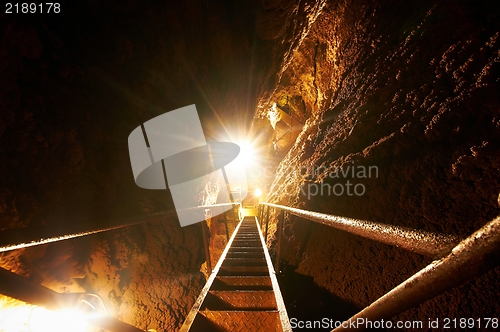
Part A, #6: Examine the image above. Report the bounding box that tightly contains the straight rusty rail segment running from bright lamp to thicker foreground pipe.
[260,202,460,258]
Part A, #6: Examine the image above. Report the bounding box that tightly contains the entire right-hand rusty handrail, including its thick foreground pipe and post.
[261,203,500,332]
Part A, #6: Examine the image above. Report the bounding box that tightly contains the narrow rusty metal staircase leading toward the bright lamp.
[181,216,292,332]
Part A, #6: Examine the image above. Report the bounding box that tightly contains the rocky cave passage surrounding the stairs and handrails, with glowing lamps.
[0,0,500,332]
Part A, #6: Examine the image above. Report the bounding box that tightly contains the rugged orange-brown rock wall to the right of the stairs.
[259,0,500,321]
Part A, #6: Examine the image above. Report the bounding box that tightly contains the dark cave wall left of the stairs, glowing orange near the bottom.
[0,0,323,331]
